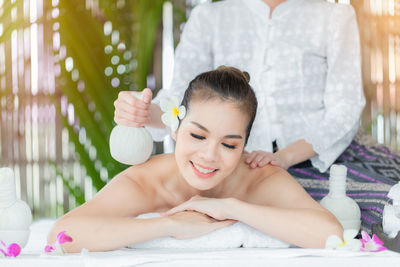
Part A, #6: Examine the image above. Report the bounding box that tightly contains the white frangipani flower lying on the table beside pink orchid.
[325,229,362,251]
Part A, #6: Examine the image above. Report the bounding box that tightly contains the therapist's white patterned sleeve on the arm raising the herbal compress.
[146,3,213,141]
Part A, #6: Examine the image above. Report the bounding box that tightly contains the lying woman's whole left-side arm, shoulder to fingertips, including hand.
[48,163,234,252]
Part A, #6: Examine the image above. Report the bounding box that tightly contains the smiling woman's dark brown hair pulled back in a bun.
[181,66,257,145]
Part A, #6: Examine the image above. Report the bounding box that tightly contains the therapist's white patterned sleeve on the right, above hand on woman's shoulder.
[305,4,365,175]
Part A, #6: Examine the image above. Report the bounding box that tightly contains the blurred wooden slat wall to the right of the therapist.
[352,0,400,150]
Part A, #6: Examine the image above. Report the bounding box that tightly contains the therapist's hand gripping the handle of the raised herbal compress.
[114,88,153,127]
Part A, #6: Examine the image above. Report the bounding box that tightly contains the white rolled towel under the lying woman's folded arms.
[128,213,289,249]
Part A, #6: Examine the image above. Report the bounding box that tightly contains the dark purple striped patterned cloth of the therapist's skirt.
[289,131,400,234]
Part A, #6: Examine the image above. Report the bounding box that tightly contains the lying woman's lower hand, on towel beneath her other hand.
[166,211,236,239]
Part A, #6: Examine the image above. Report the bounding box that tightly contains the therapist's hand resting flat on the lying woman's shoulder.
[244,150,291,170]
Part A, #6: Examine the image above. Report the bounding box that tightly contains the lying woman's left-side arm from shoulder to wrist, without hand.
[48,172,166,252]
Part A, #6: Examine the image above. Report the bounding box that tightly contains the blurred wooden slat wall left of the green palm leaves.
[0,0,91,218]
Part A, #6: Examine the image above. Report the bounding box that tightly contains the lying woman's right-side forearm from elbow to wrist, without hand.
[223,198,343,248]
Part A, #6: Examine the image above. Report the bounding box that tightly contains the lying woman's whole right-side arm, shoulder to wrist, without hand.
[226,166,343,248]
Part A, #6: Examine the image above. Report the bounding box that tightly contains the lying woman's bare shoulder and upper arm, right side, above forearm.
[242,164,323,213]
